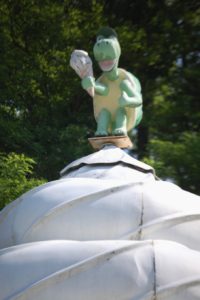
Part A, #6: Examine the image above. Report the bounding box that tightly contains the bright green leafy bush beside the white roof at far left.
[0,153,45,209]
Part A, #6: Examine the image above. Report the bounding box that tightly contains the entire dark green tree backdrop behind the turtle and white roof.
[0,0,200,207]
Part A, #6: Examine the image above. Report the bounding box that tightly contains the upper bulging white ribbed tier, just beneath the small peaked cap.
[0,178,200,250]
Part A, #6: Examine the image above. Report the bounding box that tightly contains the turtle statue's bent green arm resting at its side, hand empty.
[119,79,142,107]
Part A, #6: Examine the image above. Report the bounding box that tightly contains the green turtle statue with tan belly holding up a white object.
[70,27,142,146]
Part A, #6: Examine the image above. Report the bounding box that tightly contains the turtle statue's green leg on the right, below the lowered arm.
[112,107,127,135]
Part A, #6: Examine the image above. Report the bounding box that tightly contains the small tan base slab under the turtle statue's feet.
[88,135,133,150]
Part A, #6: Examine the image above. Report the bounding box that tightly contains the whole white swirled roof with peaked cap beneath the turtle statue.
[0,146,200,300]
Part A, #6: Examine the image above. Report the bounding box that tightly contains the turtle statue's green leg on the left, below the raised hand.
[95,108,111,136]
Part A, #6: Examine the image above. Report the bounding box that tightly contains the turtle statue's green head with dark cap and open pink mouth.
[93,27,121,72]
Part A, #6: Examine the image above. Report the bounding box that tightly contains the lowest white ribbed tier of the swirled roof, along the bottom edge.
[0,241,200,300]
